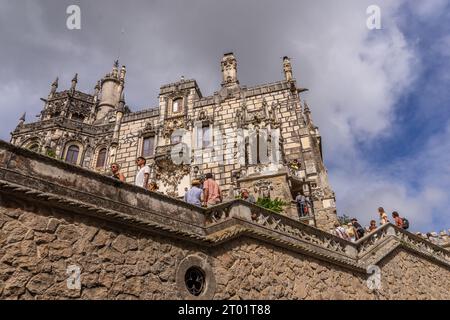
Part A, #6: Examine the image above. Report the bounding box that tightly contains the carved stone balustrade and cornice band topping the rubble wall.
[0,141,450,272]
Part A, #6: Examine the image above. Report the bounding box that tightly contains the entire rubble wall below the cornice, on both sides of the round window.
[0,199,450,300]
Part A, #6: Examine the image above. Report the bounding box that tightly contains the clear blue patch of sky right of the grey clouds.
[328,1,450,231]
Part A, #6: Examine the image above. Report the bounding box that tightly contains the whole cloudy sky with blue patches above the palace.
[0,0,450,231]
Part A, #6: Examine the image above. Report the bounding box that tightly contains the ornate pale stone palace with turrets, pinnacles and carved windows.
[11,53,336,230]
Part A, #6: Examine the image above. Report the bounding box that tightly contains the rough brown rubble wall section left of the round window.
[0,203,197,299]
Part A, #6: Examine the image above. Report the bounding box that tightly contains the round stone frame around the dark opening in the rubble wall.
[175,253,217,300]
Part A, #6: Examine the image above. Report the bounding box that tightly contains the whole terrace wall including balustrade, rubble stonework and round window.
[0,141,450,300]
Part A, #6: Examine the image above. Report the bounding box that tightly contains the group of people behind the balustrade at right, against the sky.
[334,207,409,242]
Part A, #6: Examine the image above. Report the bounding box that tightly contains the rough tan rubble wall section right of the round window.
[215,239,450,300]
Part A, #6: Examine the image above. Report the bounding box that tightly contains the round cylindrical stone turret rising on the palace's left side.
[96,60,126,120]
